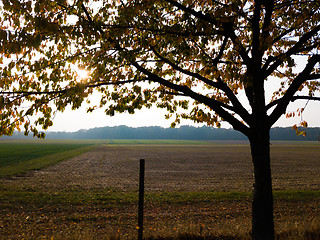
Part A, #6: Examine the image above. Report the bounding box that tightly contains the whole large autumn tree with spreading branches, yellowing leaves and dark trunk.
[0,0,320,239]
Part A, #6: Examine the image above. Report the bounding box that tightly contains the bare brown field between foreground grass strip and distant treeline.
[2,144,320,191]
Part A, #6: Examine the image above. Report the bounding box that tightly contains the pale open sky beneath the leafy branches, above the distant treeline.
[48,96,320,132]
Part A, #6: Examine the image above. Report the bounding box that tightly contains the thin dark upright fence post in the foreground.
[138,159,145,240]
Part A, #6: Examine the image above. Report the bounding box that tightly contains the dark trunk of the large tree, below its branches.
[249,128,275,240]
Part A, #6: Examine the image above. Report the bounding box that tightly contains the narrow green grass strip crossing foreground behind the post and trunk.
[0,188,320,206]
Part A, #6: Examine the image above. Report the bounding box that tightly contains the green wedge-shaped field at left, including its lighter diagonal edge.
[0,140,102,177]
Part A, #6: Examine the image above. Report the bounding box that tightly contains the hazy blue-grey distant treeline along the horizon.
[5,126,320,141]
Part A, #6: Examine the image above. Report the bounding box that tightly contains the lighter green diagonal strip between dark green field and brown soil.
[0,145,95,177]
